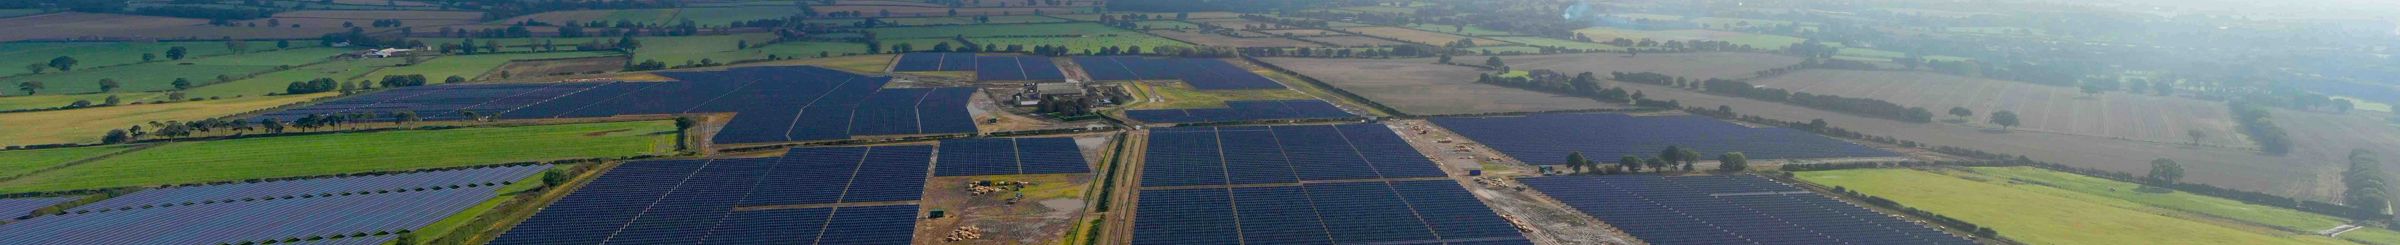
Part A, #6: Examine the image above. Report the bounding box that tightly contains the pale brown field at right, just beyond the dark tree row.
[1752,70,2251,149]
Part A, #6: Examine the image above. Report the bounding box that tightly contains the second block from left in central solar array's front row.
[1234,187,1334,245]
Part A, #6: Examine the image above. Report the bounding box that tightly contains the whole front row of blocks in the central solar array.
[1133,180,1531,245]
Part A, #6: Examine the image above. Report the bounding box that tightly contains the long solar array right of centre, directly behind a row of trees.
[1433,113,1898,163]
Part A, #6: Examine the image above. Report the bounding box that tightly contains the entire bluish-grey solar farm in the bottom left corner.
[0,166,550,245]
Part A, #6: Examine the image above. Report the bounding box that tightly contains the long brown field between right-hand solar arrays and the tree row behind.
[1615,82,2350,199]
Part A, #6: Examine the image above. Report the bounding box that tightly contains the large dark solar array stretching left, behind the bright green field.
[259,67,974,144]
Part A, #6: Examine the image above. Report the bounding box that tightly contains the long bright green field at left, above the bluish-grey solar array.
[0,120,674,192]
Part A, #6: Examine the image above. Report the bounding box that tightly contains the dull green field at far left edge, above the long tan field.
[0,43,343,96]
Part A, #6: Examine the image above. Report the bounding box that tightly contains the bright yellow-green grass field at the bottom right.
[1798,168,2342,245]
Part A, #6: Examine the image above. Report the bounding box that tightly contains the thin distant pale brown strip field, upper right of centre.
[1452,53,1800,79]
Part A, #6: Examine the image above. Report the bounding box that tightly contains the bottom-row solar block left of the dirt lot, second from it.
[703,207,833,245]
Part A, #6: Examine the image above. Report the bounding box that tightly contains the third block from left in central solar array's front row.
[1306,183,1435,243]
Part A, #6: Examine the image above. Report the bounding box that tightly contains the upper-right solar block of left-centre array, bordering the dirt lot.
[842,147,934,202]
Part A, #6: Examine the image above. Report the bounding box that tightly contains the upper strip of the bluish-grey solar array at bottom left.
[77,166,550,211]
